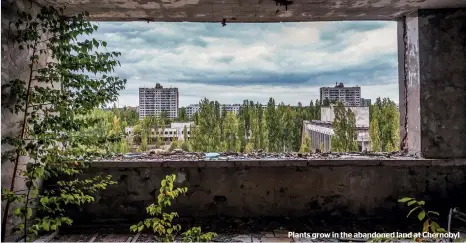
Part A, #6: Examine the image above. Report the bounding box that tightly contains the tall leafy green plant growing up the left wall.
[2,6,126,241]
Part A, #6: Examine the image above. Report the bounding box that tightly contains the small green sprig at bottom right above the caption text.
[398,197,447,233]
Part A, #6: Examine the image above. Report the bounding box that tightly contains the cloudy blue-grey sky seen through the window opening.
[95,21,398,106]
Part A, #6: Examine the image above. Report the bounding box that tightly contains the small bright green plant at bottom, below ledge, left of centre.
[130,174,217,242]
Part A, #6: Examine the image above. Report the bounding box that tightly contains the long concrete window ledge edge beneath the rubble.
[90,159,466,168]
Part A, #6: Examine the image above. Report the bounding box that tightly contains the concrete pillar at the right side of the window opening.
[398,9,466,158]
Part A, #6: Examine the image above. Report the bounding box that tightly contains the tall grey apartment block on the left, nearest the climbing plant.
[139,83,179,119]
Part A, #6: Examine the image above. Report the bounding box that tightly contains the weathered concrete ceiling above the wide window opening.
[36,0,466,21]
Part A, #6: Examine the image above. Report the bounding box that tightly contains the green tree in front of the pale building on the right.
[332,102,358,152]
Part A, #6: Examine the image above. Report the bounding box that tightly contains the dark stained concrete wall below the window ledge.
[58,160,466,224]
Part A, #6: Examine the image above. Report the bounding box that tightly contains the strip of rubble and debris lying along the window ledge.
[96,149,422,162]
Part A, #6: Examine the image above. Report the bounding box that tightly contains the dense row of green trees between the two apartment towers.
[190,98,320,152]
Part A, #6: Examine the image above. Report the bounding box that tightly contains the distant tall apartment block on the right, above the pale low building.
[320,83,361,106]
